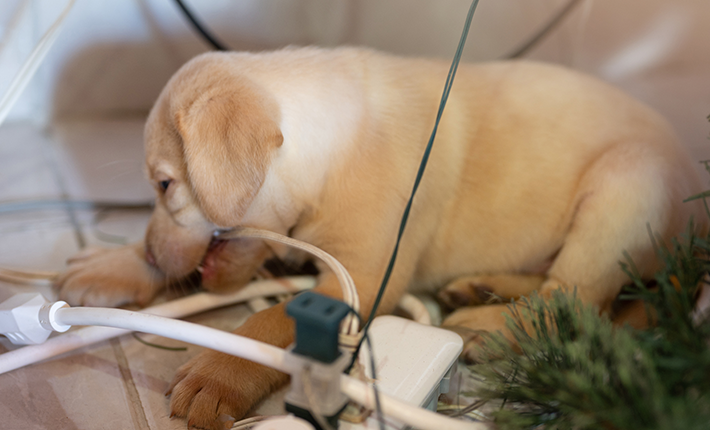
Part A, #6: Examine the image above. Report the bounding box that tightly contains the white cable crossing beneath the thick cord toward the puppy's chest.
[0,276,316,374]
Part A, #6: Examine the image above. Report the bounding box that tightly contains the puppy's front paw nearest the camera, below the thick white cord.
[166,351,288,430]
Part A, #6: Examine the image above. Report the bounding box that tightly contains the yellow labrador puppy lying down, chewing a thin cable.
[57,48,704,428]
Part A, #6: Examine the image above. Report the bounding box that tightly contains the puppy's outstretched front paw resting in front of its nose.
[54,244,165,307]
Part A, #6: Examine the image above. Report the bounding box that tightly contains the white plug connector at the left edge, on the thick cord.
[0,293,71,345]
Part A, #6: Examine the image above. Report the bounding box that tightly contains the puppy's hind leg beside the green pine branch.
[442,144,705,361]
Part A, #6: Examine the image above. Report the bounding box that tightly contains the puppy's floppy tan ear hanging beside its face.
[175,82,283,227]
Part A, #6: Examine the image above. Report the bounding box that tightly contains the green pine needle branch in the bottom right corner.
[474,220,710,430]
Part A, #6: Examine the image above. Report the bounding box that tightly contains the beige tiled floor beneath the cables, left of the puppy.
[0,119,290,430]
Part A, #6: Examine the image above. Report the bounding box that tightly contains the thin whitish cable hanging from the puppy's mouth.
[217,227,360,336]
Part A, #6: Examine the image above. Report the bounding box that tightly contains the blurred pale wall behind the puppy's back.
[0,0,710,158]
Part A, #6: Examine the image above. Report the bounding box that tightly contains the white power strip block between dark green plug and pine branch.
[339,316,463,430]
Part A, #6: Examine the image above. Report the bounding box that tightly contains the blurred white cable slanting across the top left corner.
[0,0,76,125]
